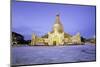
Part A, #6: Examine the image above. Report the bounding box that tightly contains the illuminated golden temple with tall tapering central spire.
[31,14,81,45]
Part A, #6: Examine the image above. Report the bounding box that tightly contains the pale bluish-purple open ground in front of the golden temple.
[11,45,96,65]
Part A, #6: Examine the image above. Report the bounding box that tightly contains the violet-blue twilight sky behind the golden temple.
[12,1,96,40]
